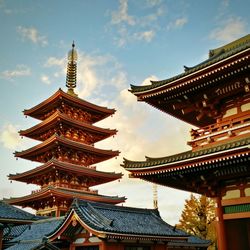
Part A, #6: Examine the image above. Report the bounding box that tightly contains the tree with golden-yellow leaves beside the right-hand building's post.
[177,194,216,250]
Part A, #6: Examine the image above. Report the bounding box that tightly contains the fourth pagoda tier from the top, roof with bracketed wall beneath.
[9,159,122,187]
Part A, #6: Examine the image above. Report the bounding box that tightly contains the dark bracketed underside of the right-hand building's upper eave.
[138,61,250,127]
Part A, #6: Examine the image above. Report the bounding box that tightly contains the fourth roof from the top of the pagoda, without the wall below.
[9,159,122,185]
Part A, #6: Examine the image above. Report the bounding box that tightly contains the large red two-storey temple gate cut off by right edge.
[123,35,250,250]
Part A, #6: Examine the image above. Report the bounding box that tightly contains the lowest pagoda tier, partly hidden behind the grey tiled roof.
[5,186,125,216]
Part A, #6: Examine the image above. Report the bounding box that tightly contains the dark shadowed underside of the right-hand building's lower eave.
[131,154,250,197]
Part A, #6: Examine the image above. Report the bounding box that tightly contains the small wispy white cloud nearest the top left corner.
[17,26,48,46]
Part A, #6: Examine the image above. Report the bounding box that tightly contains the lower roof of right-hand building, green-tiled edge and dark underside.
[123,137,250,194]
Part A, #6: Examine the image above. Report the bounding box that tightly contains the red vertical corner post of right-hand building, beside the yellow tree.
[216,196,227,250]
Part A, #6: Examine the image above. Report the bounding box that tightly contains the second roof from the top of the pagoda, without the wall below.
[19,110,117,142]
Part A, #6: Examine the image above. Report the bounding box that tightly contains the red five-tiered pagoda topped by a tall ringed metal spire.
[6,43,125,217]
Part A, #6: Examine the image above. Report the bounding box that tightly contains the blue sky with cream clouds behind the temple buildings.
[0,0,250,225]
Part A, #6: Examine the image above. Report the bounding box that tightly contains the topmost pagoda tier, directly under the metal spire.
[23,89,115,124]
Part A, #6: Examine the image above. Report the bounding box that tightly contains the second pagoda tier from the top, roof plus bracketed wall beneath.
[19,110,117,144]
